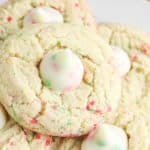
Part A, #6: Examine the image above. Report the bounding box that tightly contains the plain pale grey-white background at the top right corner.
[87,0,150,32]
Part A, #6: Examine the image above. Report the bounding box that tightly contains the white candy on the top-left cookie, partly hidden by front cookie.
[24,6,64,26]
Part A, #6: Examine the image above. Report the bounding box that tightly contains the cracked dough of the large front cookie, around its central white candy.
[0,24,121,137]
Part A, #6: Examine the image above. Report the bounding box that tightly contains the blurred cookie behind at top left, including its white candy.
[0,0,96,39]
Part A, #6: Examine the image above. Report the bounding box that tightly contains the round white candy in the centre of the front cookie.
[40,49,84,92]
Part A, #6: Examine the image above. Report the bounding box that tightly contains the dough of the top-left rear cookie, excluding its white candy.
[0,0,96,39]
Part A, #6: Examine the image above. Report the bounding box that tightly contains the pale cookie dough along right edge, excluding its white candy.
[99,24,150,150]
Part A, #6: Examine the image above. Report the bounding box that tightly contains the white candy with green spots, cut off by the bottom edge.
[81,124,128,150]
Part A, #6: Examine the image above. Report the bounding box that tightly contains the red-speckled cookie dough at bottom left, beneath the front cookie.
[0,105,81,150]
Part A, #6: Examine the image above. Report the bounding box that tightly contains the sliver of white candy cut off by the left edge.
[0,106,7,129]
